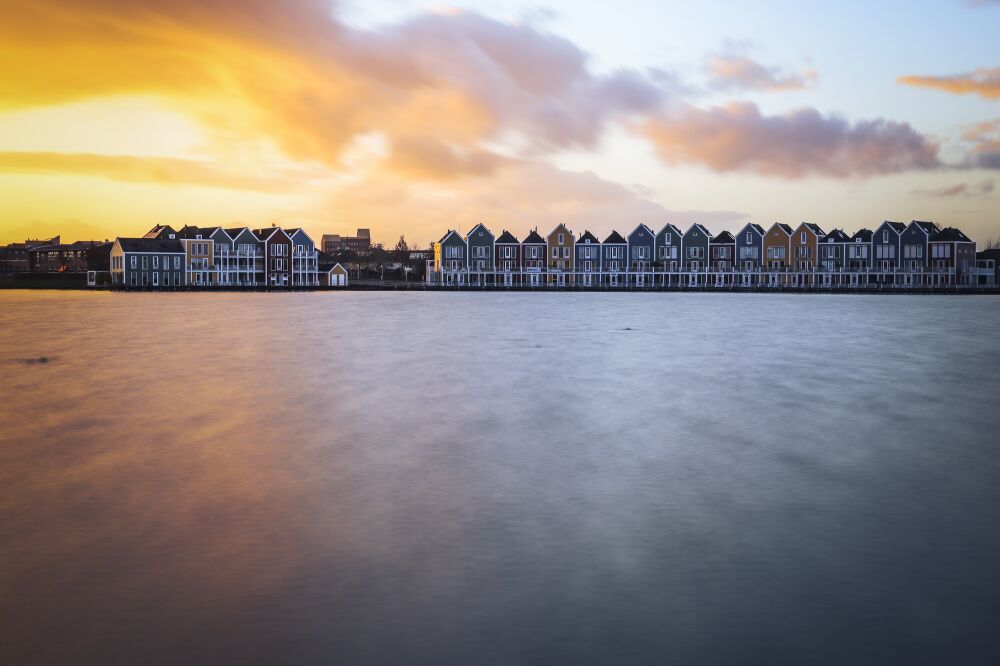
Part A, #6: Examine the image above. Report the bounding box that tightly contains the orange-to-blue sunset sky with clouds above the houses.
[0,0,1000,246]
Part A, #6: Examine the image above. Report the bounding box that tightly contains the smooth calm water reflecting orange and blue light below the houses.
[0,292,1000,665]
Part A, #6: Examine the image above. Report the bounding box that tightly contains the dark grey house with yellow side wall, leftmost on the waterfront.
[111,238,186,289]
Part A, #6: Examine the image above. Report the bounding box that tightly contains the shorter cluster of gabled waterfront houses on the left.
[110,225,348,289]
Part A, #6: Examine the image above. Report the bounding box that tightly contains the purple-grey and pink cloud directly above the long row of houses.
[643,102,941,179]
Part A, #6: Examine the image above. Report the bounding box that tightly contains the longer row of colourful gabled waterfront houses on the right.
[426,220,996,288]
